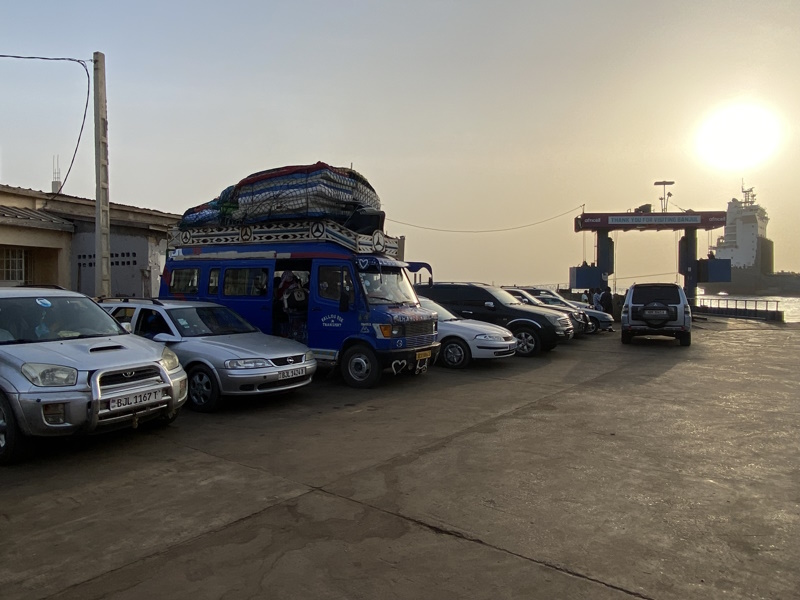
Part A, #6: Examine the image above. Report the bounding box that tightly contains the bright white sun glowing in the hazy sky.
[696,104,781,171]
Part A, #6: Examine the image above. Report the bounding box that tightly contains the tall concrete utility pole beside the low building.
[92,52,111,296]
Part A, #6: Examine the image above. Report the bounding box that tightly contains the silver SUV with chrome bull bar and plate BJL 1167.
[0,287,187,463]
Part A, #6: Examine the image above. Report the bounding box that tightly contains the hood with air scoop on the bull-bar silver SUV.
[0,334,164,371]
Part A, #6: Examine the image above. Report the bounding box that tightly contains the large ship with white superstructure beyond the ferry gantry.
[702,186,800,296]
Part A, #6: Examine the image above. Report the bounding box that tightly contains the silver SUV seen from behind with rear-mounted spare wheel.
[621,283,692,346]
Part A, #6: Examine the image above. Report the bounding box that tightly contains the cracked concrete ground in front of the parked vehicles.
[0,319,800,600]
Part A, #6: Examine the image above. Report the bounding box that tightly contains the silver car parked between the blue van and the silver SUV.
[100,298,317,412]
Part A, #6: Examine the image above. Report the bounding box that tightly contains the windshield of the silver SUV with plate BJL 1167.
[0,292,125,344]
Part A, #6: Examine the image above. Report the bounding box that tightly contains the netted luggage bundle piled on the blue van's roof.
[179,162,382,229]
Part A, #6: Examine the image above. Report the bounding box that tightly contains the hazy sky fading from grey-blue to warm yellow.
[0,0,800,287]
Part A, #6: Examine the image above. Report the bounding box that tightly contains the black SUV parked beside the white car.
[414,283,574,356]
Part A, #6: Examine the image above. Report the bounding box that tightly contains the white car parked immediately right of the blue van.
[419,297,517,369]
